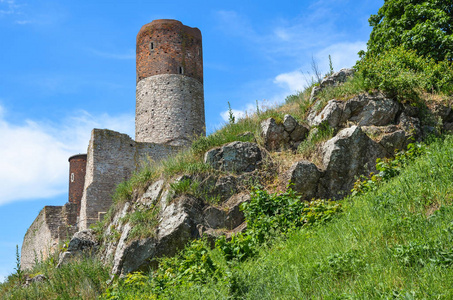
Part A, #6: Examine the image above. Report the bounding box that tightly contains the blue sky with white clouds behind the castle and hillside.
[0,0,384,280]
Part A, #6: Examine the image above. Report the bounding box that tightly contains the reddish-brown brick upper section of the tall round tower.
[136,19,203,83]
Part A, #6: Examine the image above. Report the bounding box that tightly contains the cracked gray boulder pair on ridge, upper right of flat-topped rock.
[261,115,309,151]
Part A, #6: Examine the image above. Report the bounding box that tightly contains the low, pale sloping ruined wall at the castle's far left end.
[20,206,64,269]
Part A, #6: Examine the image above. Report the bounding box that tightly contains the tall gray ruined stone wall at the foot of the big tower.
[79,129,180,230]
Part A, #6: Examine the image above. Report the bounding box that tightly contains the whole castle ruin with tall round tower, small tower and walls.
[21,20,205,268]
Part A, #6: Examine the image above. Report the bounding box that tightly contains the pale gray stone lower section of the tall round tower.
[135,75,205,146]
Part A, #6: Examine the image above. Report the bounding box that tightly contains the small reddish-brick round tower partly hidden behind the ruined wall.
[68,154,87,217]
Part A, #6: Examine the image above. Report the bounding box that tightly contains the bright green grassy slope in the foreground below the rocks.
[100,136,453,299]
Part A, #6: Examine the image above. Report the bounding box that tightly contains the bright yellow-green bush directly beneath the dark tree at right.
[356,47,453,100]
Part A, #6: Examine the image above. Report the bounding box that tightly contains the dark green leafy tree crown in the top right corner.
[367,0,453,61]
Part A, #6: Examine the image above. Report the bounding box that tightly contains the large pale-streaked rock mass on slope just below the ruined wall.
[93,175,250,276]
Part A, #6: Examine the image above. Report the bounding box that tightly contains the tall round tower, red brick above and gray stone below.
[135,20,206,146]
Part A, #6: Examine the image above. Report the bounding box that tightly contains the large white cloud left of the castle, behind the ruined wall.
[0,106,134,205]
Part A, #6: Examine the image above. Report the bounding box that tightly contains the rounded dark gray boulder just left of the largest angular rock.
[284,161,321,200]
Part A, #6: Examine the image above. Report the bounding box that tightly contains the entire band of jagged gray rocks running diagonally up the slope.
[47,77,453,276]
